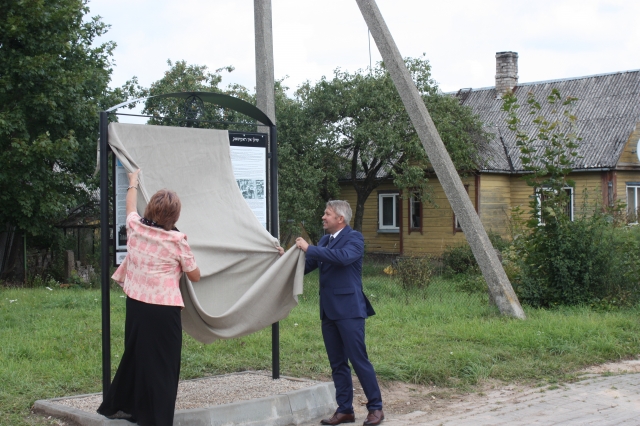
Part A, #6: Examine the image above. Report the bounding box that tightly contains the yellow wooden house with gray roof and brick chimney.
[341,52,640,255]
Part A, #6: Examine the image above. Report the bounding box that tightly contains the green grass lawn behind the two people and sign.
[0,269,640,426]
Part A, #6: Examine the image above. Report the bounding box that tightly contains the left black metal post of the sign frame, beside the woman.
[100,111,111,397]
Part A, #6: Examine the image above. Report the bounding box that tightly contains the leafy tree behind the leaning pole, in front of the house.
[296,58,487,230]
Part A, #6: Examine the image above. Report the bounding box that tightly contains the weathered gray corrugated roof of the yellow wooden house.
[456,70,640,173]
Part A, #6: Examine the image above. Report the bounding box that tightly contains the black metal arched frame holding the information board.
[99,92,280,396]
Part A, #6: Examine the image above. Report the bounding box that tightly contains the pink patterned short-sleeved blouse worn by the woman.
[111,212,197,307]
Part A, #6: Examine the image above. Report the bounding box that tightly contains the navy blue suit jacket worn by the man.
[304,225,375,320]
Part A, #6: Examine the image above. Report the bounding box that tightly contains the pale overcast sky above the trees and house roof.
[89,0,640,100]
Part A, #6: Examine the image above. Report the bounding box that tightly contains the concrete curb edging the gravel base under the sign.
[33,377,336,426]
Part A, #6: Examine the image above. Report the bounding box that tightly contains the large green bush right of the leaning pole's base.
[513,213,640,309]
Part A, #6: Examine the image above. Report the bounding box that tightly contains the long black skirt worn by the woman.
[98,297,182,426]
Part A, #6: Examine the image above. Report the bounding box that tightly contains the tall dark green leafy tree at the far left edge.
[0,0,115,235]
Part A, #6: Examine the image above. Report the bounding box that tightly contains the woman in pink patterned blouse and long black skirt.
[98,170,200,426]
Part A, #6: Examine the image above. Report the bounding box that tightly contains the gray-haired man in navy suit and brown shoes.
[296,200,384,426]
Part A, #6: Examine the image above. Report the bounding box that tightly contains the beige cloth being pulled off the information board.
[109,123,304,343]
